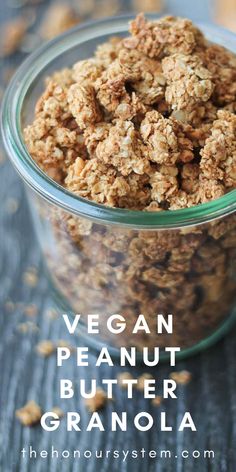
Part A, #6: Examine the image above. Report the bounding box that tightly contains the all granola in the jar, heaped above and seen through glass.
[24,15,236,349]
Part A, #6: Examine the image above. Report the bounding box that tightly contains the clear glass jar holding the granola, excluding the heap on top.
[2,16,236,357]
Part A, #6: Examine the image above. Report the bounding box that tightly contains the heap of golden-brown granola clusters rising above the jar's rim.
[25,14,236,211]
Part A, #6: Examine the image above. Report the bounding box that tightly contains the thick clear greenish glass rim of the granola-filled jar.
[1,15,236,229]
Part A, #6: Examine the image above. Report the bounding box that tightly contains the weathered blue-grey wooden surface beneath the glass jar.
[0,2,236,472]
